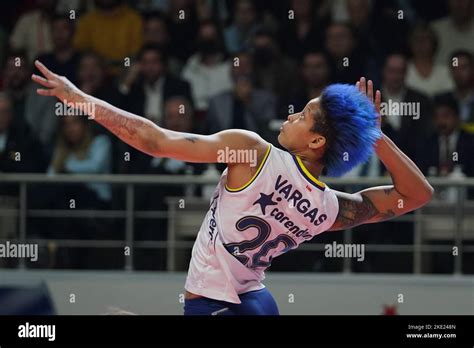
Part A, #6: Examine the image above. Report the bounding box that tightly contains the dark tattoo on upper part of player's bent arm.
[335,194,395,229]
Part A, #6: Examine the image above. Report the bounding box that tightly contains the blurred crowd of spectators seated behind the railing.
[0,0,474,272]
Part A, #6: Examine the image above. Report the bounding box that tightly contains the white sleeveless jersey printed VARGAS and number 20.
[185,144,339,303]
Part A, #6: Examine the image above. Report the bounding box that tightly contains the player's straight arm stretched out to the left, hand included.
[32,61,267,163]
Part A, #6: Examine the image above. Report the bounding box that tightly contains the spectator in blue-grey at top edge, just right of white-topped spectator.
[224,0,259,54]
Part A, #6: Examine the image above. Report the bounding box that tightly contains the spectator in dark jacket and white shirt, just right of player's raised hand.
[381,53,433,158]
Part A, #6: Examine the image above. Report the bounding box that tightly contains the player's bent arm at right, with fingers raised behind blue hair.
[330,78,434,230]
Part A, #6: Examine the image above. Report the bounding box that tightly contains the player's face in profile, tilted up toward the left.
[278,98,324,152]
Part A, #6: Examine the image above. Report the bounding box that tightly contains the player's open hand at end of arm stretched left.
[31,60,84,103]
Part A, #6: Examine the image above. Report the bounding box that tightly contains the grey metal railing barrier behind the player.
[0,174,474,274]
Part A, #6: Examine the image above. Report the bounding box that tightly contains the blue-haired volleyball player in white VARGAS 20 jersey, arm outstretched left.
[32,62,433,315]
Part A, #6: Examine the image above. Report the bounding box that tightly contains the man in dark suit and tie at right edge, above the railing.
[419,96,474,176]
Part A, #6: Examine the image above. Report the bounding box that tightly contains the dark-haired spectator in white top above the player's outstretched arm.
[182,21,232,114]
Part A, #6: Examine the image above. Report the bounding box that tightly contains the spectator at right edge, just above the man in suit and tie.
[436,50,474,133]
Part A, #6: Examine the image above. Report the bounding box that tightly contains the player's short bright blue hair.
[315,84,381,177]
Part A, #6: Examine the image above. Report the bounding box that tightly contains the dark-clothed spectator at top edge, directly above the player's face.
[278,0,328,60]
